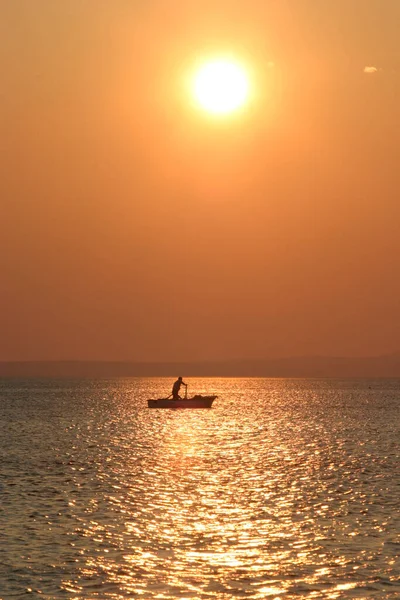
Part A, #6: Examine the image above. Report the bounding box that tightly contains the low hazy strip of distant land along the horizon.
[0,354,400,378]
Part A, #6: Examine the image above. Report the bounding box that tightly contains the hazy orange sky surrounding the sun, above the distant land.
[0,0,400,360]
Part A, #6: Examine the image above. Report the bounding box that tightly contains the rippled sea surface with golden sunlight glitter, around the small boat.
[0,379,400,600]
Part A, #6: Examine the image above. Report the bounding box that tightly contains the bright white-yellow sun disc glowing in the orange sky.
[193,59,249,115]
